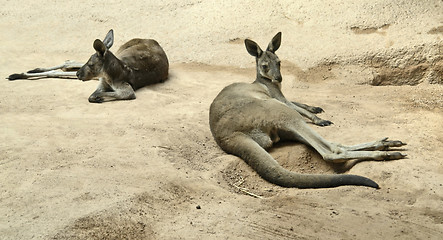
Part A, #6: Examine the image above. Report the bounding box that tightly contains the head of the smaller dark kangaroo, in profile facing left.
[77,29,114,81]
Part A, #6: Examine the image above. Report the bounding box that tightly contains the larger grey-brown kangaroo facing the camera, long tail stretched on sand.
[209,32,406,188]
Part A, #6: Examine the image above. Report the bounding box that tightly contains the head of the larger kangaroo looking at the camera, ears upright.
[245,32,282,83]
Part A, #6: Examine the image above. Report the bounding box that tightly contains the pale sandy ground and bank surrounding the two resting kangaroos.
[0,0,443,239]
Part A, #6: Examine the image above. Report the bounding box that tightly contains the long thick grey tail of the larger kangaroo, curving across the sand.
[224,135,379,188]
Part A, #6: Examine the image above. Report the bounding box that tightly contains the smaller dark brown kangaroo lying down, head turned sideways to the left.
[9,29,169,103]
